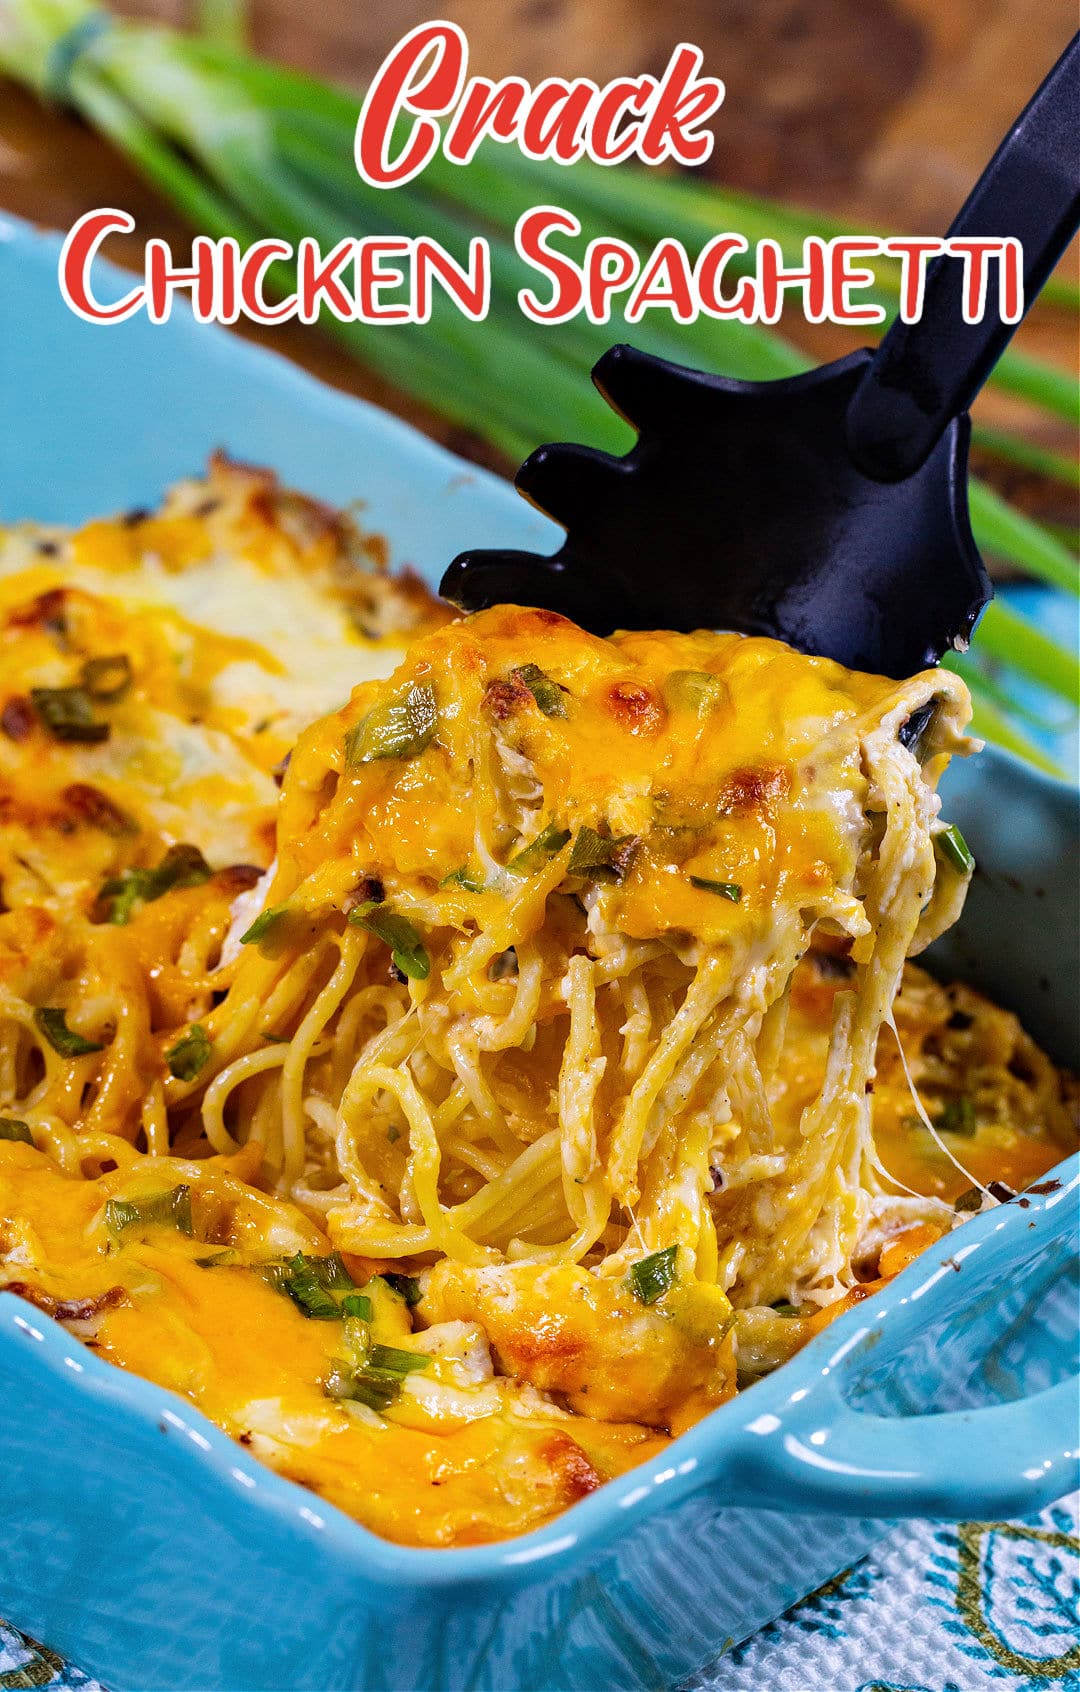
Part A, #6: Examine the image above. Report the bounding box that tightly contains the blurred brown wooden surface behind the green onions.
[0,0,1077,521]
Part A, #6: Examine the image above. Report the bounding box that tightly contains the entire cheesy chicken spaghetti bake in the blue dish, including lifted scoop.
[0,477,1075,1545]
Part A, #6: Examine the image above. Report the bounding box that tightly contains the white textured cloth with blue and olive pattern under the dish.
[0,1497,1080,1692]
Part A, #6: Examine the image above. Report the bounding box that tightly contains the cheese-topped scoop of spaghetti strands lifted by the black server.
[184,606,968,1420]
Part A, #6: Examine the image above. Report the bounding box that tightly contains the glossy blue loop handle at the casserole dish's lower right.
[731,1354,1080,1521]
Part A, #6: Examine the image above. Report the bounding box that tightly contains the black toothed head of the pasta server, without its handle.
[442,347,992,677]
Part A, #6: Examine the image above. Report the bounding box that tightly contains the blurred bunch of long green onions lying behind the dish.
[0,0,1080,773]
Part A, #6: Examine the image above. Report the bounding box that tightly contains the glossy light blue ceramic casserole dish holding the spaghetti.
[0,218,1080,1692]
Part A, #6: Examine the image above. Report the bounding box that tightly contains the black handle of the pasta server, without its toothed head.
[846,36,1080,482]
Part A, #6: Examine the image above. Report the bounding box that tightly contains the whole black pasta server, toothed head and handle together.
[442,36,1080,677]
